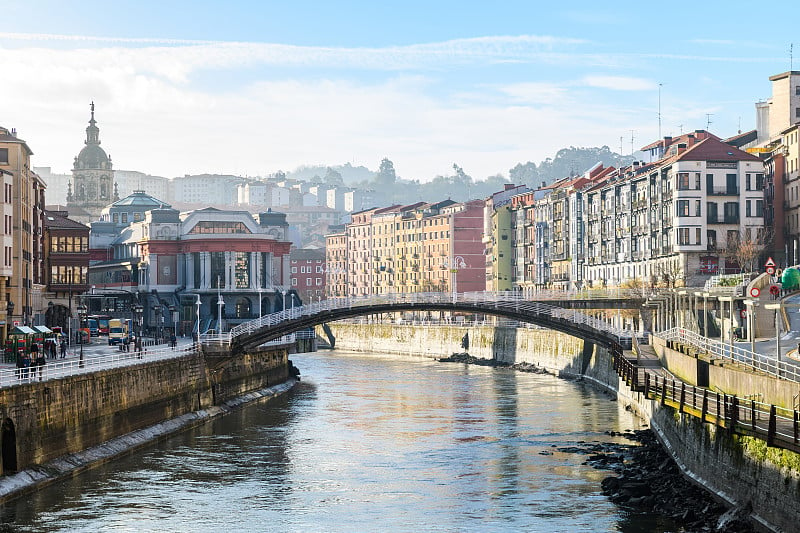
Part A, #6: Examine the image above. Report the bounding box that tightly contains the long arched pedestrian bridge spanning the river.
[201,292,641,354]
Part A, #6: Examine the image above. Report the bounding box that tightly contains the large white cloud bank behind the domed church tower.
[0,36,664,180]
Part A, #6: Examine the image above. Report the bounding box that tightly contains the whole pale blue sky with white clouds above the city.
[0,0,800,181]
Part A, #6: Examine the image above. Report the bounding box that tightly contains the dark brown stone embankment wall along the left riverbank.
[0,344,288,474]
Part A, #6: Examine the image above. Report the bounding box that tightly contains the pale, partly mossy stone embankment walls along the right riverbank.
[330,323,800,531]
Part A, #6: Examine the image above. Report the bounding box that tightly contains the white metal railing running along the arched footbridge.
[214,290,642,343]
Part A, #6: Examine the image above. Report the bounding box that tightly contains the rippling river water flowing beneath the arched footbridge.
[0,352,670,533]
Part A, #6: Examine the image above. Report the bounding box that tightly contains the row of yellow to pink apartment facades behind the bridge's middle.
[326,200,485,296]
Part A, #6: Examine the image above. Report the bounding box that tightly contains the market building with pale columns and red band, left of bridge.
[90,207,291,334]
